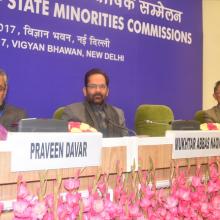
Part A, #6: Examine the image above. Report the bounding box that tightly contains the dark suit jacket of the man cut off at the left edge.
[0,104,27,131]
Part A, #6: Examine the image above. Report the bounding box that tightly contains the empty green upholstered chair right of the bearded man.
[135,105,174,136]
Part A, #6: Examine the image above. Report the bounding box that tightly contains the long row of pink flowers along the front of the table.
[0,161,220,220]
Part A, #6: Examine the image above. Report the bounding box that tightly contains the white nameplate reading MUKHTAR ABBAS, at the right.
[166,131,220,159]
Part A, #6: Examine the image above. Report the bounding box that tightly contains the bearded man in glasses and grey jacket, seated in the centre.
[62,69,128,137]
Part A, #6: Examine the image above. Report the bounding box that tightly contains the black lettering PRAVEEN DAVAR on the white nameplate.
[30,141,87,159]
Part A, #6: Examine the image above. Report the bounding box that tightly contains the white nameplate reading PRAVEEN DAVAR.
[10,132,102,172]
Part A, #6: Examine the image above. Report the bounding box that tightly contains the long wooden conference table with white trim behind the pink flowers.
[0,131,220,217]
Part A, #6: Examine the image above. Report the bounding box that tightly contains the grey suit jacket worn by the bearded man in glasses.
[61,102,128,136]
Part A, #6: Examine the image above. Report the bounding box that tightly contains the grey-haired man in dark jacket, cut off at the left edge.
[0,69,26,131]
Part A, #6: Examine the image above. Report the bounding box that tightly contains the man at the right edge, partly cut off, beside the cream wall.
[204,81,220,123]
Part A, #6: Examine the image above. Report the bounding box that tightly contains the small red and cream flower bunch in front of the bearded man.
[68,121,97,133]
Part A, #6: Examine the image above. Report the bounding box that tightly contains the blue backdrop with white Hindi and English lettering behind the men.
[0,0,202,128]
